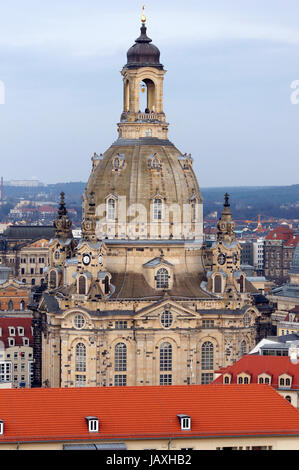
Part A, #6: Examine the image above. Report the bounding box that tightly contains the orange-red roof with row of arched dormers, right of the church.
[213,354,299,389]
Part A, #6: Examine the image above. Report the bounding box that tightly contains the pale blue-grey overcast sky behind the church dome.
[0,0,299,187]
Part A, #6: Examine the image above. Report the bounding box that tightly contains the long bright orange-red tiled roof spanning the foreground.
[0,384,299,444]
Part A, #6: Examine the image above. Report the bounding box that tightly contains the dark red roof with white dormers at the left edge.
[0,317,33,348]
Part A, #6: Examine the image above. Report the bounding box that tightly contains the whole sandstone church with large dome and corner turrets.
[34,15,261,387]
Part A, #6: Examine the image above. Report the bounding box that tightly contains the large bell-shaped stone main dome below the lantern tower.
[83,138,202,239]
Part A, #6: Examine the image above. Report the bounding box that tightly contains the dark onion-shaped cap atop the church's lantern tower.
[126,25,163,69]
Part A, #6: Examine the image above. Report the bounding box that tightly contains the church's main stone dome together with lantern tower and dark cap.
[83,19,203,240]
